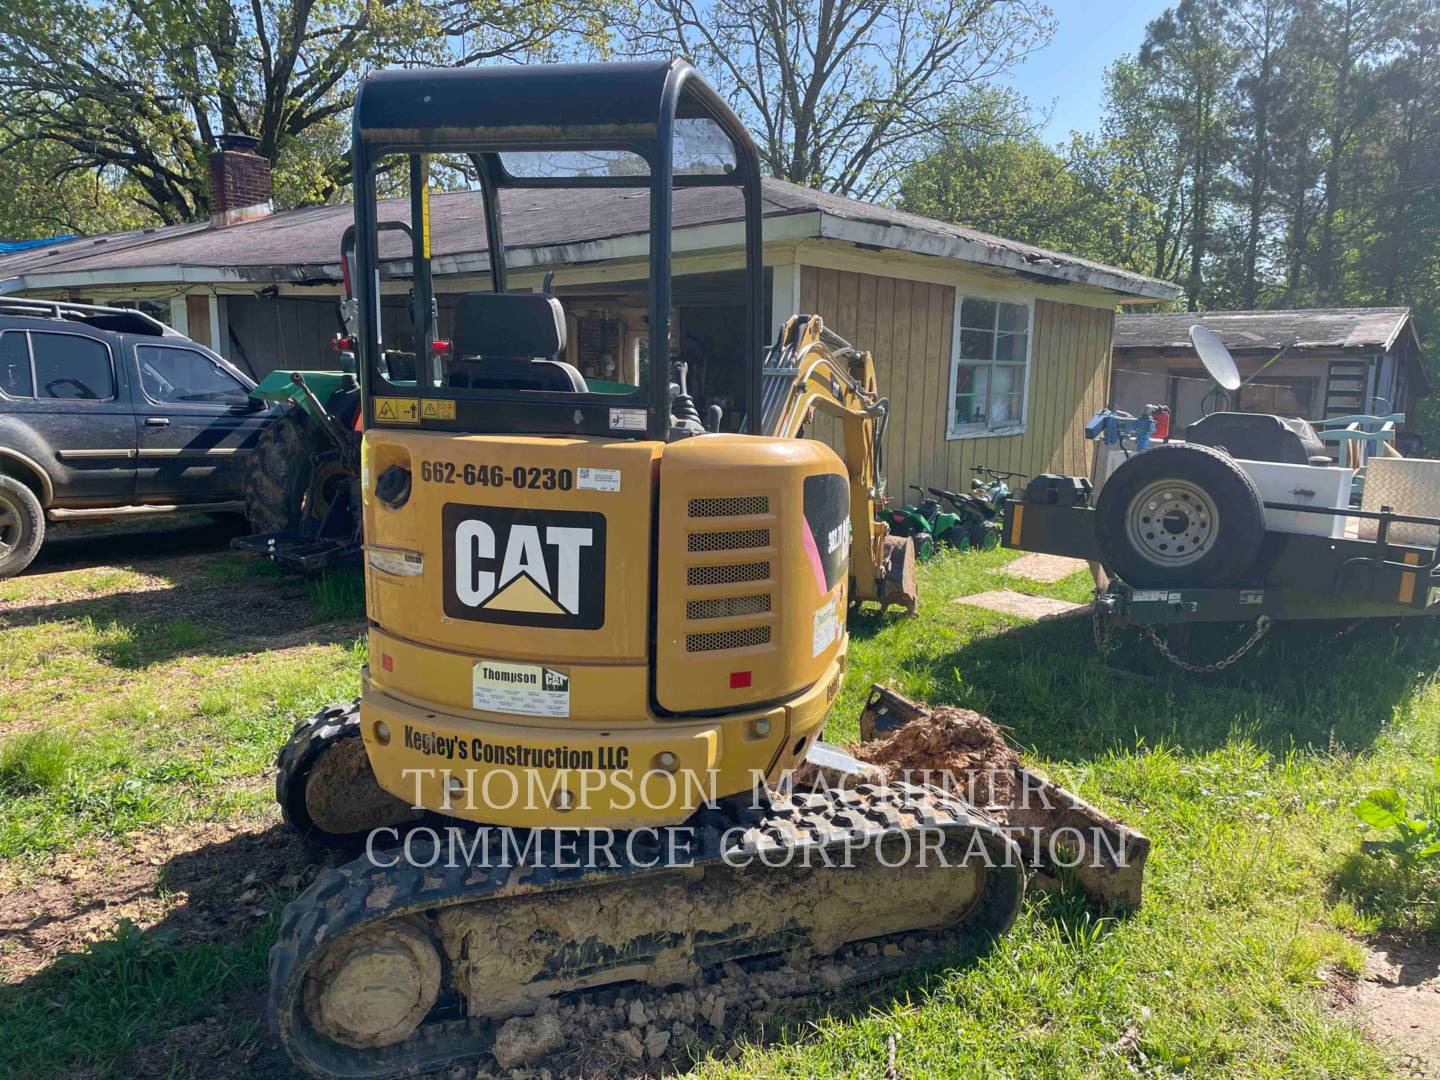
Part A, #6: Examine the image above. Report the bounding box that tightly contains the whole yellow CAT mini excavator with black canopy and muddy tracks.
[269,62,1024,1077]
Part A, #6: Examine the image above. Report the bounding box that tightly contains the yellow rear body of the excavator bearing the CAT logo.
[360,429,851,828]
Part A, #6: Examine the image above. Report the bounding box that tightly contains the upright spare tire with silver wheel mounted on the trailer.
[1094,444,1264,589]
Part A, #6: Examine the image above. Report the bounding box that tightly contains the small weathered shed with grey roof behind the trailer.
[1110,308,1430,432]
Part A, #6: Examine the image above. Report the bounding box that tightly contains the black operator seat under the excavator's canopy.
[446,292,589,393]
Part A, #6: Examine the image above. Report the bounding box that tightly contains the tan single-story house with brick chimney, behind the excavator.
[0,139,1179,495]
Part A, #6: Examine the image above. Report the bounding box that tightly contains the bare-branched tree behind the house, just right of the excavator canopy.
[629,0,1051,199]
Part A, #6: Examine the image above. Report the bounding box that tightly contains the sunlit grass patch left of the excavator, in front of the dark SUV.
[0,553,364,864]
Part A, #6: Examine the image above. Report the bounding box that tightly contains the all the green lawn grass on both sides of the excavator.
[0,552,1440,1080]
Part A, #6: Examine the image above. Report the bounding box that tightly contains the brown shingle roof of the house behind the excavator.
[0,180,1179,300]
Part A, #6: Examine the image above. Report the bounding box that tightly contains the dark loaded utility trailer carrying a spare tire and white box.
[1002,316,1440,672]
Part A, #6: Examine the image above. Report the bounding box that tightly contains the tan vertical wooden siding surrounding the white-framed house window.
[799,266,1115,500]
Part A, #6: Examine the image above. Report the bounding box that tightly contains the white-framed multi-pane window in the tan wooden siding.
[948,297,1031,439]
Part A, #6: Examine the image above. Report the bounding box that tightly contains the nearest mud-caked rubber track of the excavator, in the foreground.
[269,783,1025,1079]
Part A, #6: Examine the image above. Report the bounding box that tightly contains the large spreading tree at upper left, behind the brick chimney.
[0,0,608,222]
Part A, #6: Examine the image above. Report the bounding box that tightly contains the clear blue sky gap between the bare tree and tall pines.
[1009,0,1175,143]
